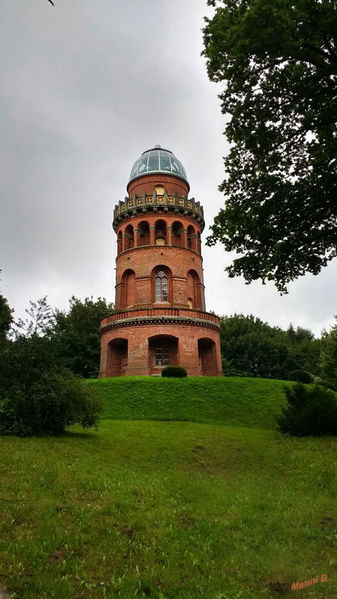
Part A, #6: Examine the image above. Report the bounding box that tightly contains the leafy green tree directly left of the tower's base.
[53,296,114,377]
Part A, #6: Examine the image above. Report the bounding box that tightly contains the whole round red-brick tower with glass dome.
[100,146,222,377]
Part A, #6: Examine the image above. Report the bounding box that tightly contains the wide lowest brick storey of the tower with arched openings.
[100,308,222,377]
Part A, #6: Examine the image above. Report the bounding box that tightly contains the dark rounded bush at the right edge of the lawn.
[277,383,337,437]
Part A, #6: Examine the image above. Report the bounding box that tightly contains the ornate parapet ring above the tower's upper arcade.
[113,190,205,230]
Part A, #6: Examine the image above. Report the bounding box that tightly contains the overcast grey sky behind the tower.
[0,0,337,334]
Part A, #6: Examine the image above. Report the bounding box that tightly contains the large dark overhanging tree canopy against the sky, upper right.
[204,0,337,292]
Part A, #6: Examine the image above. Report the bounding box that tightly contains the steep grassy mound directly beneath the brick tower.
[88,377,290,428]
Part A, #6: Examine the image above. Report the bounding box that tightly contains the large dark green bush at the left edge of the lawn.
[0,337,102,436]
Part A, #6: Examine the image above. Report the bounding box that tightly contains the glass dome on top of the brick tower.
[129,145,188,183]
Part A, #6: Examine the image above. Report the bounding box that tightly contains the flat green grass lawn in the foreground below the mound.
[0,418,337,599]
